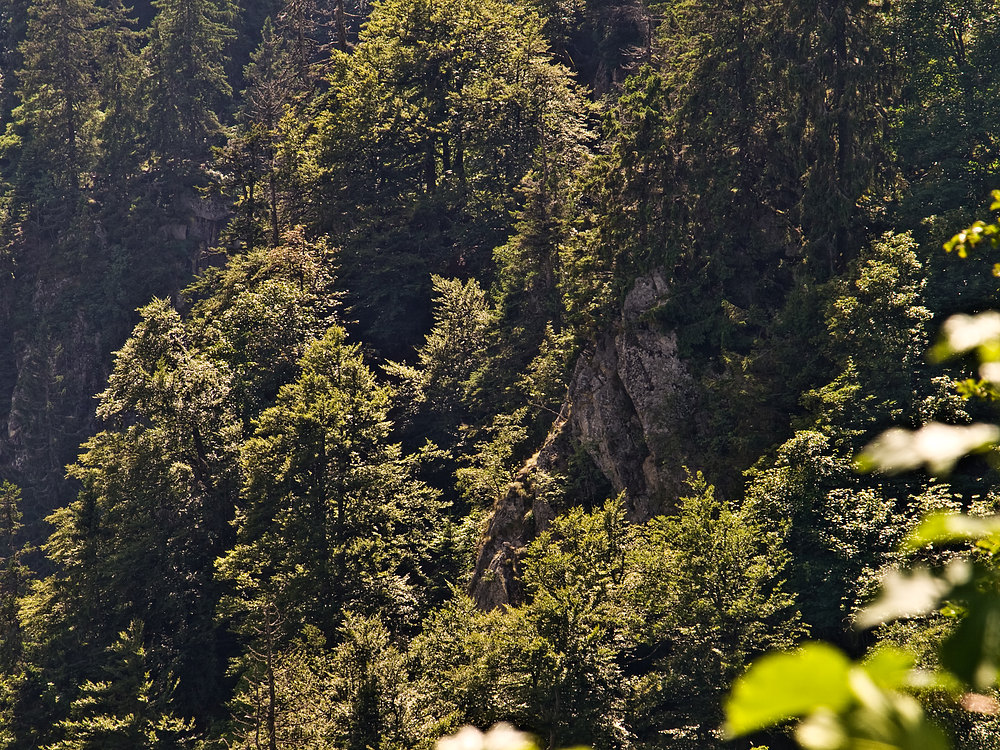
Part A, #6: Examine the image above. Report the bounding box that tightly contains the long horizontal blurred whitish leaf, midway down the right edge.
[857,422,1000,475]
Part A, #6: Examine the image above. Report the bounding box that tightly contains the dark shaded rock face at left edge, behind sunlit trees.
[0,191,221,542]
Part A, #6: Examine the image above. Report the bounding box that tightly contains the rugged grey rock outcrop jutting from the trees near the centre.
[469,273,696,609]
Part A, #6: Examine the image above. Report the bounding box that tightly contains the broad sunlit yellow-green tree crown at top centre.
[316,0,567,210]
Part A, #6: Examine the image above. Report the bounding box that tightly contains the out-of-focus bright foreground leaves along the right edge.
[727,216,1000,749]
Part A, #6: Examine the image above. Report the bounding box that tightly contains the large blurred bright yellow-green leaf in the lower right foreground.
[726,643,852,737]
